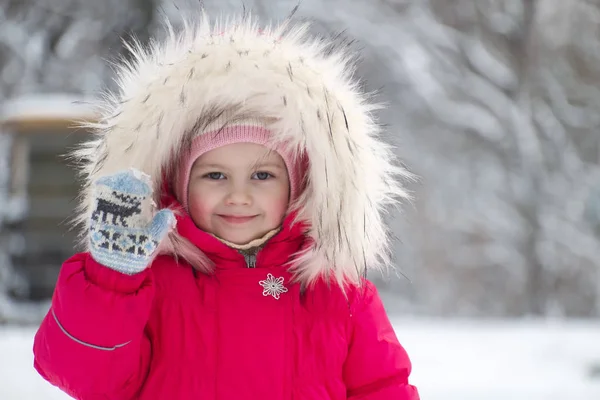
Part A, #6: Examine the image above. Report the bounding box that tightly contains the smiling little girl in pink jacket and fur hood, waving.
[34,12,419,400]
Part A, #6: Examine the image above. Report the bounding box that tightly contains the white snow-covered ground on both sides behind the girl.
[0,319,600,400]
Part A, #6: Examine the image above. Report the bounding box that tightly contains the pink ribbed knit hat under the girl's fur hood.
[174,118,303,210]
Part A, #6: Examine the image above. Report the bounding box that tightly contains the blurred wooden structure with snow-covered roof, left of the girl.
[0,96,94,299]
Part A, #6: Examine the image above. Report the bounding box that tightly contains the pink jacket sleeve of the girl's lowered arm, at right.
[343,281,419,400]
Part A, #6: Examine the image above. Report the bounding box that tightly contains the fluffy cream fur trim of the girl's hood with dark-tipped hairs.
[74,14,410,284]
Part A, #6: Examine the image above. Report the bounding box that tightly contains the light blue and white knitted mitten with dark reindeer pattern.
[89,169,175,275]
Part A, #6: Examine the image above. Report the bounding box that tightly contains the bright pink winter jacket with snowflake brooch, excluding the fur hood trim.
[34,206,419,400]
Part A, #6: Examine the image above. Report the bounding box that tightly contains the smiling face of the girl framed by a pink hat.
[188,143,290,245]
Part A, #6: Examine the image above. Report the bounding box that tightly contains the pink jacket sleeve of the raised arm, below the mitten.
[33,253,154,400]
